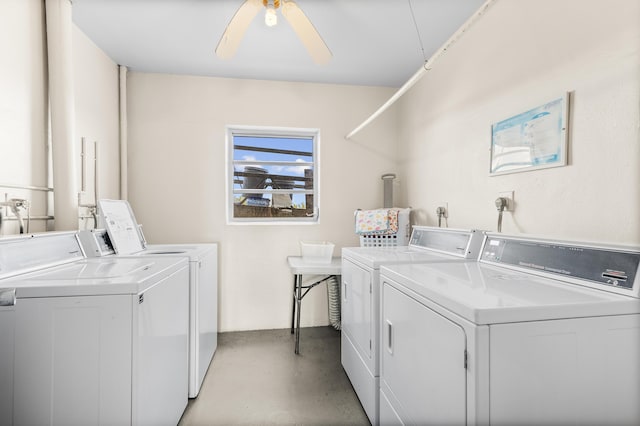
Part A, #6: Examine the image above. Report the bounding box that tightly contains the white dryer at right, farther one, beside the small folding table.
[341,226,483,425]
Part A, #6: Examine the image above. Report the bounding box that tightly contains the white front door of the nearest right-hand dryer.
[380,283,467,425]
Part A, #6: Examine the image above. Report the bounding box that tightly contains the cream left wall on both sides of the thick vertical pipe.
[0,0,119,235]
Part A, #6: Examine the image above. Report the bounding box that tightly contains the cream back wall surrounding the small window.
[127,73,395,331]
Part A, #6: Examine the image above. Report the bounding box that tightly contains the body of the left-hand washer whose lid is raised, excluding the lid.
[79,229,218,398]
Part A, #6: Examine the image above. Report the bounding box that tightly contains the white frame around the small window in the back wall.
[225,125,320,225]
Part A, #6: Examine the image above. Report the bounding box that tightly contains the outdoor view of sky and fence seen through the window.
[233,134,315,218]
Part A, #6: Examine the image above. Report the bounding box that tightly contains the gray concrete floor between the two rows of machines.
[179,327,370,426]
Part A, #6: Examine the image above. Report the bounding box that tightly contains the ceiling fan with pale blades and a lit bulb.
[216,0,332,64]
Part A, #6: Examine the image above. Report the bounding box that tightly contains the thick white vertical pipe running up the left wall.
[45,0,78,230]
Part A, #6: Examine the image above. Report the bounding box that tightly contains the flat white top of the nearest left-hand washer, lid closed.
[8,256,188,303]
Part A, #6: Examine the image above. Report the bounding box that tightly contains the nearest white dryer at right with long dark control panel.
[380,234,640,425]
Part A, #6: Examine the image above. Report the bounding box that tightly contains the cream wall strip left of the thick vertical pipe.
[0,0,48,235]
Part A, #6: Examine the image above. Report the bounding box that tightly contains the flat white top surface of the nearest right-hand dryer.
[380,262,640,324]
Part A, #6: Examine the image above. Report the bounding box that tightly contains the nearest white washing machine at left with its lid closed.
[0,233,189,425]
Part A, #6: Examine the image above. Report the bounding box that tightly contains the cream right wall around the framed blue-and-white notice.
[398,0,640,244]
